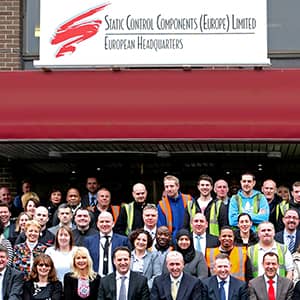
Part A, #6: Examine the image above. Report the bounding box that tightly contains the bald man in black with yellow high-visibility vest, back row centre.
[114,183,148,236]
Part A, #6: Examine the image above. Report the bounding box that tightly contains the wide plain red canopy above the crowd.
[0,70,300,141]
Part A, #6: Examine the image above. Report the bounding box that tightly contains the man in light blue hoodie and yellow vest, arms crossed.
[228,173,270,231]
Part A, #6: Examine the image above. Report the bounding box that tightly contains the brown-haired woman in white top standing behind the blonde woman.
[45,226,77,282]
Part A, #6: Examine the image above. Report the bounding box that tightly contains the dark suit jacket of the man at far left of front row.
[3,267,24,300]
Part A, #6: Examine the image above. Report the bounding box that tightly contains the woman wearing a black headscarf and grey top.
[173,229,208,279]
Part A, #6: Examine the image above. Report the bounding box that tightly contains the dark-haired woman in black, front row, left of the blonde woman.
[23,254,62,300]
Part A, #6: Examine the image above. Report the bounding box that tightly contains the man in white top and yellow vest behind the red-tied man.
[248,222,294,279]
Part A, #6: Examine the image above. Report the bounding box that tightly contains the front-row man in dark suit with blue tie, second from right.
[203,253,249,300]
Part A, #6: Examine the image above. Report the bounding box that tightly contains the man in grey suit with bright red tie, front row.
[249,252,293,300]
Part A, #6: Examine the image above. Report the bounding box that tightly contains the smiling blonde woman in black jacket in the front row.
[64,247,100,300]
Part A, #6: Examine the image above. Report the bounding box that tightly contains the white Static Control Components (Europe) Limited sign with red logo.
[35,0,270,68]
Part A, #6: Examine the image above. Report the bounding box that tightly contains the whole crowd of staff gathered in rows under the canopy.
[0,173,300,300]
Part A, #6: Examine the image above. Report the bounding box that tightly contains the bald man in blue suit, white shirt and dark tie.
[84,211,128,276]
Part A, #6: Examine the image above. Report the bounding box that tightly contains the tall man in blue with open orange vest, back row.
[157,175,193,242]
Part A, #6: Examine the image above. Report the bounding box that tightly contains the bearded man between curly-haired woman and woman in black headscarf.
[152,226,172,269]
